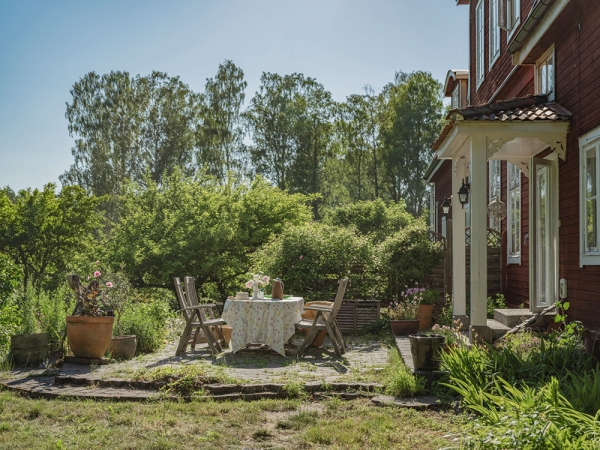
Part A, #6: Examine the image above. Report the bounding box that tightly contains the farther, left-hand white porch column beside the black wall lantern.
[452,156,467,318]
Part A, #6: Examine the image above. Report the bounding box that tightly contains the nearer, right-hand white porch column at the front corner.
[469,135,488,327]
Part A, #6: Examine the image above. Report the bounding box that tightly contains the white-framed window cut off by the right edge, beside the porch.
[579,127,600,267]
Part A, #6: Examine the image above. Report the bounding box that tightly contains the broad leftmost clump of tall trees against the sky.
[60,72,200,196]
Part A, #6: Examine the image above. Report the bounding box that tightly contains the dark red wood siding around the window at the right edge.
[545,0,600,329]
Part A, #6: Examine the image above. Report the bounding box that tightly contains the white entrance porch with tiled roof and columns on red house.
[433,96,570,340]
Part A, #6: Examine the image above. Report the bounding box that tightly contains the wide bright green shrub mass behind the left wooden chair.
[108,173,310,299]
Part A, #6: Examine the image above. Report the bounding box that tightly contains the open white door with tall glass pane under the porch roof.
[529,158,558,312]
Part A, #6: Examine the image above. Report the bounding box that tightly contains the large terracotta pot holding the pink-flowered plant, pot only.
[67,316,115,359]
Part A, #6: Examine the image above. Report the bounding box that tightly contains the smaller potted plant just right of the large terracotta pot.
[106,272,137,359]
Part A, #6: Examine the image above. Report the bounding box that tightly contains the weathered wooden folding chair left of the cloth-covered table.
[174,277,227,356]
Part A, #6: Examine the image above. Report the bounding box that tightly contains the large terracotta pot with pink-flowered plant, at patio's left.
[66,268,115,359]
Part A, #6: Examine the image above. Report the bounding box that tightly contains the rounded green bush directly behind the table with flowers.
[254,223,372,300]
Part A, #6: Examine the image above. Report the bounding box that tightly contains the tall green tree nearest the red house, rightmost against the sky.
[385,72,443,216]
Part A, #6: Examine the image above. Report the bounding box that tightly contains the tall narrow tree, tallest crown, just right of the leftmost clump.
[198,60,248,180]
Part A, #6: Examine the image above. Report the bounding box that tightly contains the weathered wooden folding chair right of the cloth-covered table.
[296,278,348,356]
